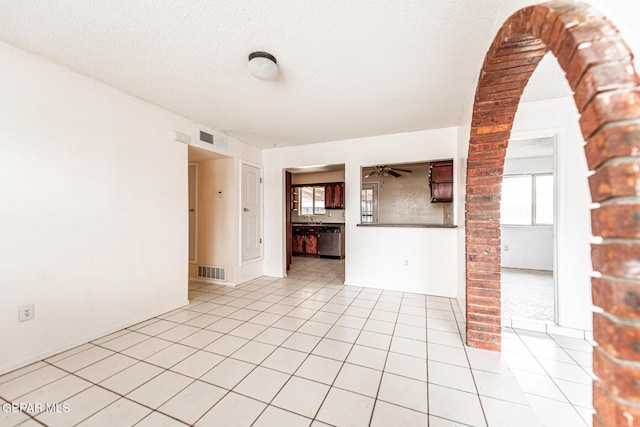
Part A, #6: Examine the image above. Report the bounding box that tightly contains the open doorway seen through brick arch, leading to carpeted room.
[500,136,557,328]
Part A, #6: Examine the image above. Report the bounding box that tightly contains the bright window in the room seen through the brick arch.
[500,174,553,225]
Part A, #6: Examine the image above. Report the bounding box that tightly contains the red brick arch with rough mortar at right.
[465,1,640,426]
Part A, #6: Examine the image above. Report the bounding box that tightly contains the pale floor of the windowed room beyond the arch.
[501,267,554,322]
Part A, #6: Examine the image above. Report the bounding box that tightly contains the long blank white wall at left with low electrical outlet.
[0,43,261,373]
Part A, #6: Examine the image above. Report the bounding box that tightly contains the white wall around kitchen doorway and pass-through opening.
[264,128,457,296]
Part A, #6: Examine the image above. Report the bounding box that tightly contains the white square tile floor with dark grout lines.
[0,258,591,427]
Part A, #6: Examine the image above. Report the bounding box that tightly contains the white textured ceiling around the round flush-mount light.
[0,0,632,147]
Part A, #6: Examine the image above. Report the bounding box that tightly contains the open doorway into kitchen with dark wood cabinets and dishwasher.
[285,164,346,283]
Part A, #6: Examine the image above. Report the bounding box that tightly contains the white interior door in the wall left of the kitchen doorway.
[242,163,262,261]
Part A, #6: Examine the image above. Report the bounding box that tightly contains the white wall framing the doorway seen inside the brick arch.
[511,98,592,330]
